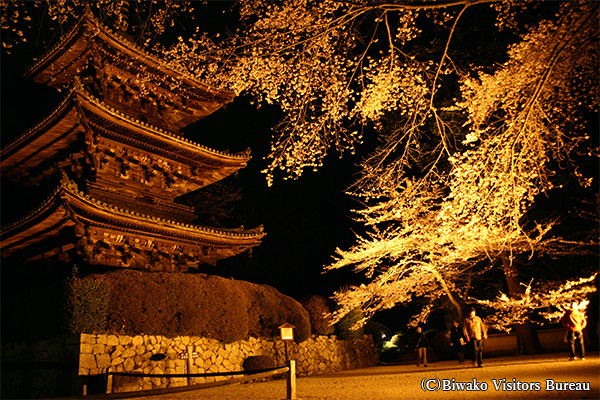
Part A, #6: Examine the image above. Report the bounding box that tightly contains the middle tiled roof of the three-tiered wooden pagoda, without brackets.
[0,85,251,196]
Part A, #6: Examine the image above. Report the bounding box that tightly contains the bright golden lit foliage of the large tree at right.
[322,3,598,328]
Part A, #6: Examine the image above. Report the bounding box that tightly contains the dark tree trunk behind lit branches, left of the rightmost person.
[502,253,544,354]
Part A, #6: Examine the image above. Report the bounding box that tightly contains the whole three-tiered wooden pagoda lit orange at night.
[0,12,265,272]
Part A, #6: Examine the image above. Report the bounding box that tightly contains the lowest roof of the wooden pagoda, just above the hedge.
[0,174,265,271]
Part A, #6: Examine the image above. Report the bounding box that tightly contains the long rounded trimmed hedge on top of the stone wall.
[68,270,310,343]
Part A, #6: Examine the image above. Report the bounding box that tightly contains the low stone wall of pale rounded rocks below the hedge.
[79,334,379,391]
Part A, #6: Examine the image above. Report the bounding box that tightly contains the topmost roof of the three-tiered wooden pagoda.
[24,12,235,129]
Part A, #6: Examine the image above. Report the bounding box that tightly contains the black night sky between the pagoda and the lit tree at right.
[187,97,370,297]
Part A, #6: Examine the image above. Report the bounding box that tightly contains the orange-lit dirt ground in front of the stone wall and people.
[138,352,600,400]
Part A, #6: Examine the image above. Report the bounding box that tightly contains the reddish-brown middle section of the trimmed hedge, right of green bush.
[106,271,249,343]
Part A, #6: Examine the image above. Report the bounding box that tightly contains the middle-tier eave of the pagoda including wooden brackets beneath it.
[0,88,250,194]
